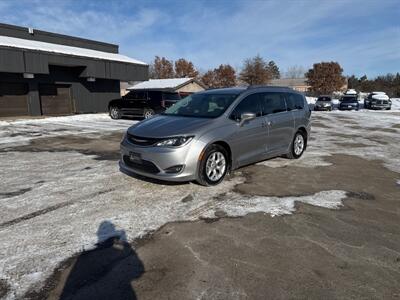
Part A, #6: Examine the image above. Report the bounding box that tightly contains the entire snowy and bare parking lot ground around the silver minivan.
[0,111,400,299]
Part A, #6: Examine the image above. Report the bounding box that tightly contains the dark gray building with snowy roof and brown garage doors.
[0,24,148,117]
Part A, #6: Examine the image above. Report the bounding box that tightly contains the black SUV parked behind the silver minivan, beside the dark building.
[108,90,181,119]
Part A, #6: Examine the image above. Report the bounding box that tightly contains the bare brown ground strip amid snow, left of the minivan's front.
[1,132,123,160]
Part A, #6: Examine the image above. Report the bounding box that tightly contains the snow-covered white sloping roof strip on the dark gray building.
[0,36,147,65]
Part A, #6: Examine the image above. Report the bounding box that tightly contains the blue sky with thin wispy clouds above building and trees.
[0,0,400,77]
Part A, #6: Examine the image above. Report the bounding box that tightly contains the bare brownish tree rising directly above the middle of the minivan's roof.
[239,55,272,85]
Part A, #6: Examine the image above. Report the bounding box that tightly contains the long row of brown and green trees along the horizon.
[150,55,400,97]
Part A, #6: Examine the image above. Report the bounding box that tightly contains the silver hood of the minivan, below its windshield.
[128,115,214,138]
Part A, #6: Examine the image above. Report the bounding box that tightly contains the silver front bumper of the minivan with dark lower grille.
[119,139,203,182]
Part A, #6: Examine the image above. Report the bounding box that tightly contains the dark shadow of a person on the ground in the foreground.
[48,221,145,300]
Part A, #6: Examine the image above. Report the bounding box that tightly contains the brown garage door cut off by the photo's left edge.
[0,82,29,117]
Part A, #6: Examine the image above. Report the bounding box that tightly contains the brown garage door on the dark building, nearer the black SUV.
[39,84,73,115]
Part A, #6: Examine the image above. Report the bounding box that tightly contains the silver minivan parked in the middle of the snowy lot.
[120,87,311,185]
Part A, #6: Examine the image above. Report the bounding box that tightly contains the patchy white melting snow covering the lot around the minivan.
[0,111,400,299]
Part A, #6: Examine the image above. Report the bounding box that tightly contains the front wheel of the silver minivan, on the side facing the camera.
[197,145,230,186]
